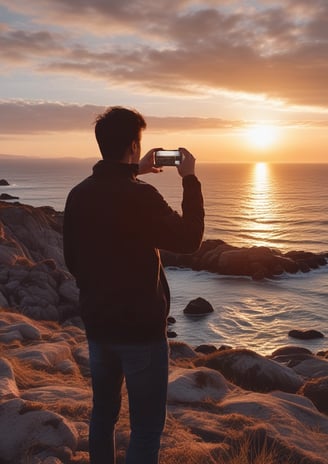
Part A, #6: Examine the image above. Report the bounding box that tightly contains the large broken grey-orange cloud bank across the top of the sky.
[0,0,328,107]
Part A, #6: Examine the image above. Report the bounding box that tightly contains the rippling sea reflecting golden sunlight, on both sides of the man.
[0,157,328,355]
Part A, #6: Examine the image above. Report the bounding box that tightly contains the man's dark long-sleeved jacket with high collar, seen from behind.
[64,160,204,343]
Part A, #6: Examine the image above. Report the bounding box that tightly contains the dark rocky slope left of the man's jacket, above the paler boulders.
[0,201,78,321]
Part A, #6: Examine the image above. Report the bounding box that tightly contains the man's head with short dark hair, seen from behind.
[95,106,146,161]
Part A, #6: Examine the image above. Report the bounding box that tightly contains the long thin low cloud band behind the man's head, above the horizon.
[0,100,328,137]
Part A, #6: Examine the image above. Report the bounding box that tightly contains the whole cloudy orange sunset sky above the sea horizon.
[0,0,328,163]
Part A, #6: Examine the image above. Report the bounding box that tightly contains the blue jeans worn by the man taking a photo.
[89,340,168,464]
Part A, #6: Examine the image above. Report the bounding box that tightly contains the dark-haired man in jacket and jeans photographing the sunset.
[64,107,204,464]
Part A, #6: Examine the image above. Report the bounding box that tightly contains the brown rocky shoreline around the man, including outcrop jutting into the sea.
[0,201,328,464]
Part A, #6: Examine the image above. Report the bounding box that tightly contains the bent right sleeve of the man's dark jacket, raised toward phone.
[147,175,204,253]
